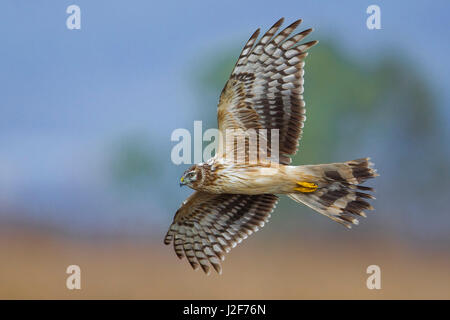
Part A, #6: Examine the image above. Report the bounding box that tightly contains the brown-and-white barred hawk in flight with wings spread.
[164,18,378,274]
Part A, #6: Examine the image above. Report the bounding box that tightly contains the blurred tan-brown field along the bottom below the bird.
[0,222,450,299]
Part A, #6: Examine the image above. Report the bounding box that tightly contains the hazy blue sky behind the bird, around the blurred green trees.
[0,0,450,235]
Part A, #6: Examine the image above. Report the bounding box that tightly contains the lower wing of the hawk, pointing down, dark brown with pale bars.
[164,191,278,274]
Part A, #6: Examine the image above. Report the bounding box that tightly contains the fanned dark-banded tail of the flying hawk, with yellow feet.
[288,158,378,228]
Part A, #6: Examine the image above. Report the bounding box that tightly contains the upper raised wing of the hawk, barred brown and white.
[217,19,317,164]
